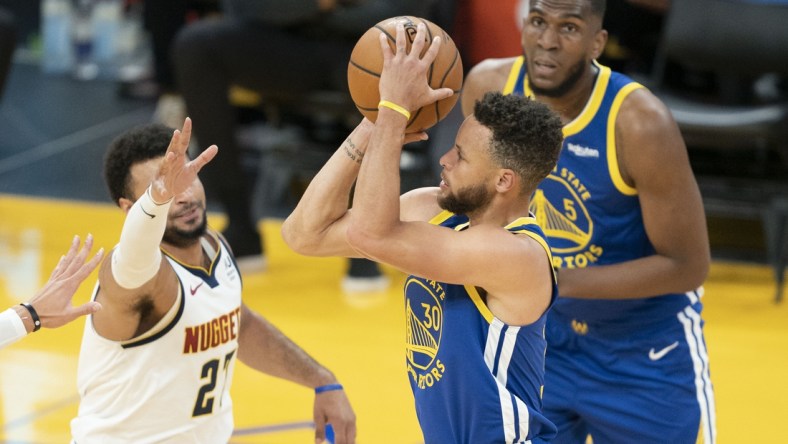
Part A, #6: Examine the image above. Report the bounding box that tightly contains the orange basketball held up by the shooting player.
[347,16,463,133]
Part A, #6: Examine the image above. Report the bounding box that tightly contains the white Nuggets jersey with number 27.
[71,232,241,444]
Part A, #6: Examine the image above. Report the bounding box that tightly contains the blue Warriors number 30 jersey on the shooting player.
[405,211,557,444]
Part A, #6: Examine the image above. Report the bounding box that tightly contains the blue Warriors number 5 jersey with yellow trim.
[503,56,698,326]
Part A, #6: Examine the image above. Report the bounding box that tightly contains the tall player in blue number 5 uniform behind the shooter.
[462,0,716,444]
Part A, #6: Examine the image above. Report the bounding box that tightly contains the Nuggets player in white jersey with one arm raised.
[71,119,355,444]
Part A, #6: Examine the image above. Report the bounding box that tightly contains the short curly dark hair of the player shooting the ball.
[473,92,564,194]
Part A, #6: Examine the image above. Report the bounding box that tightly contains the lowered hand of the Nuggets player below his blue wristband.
[314,390,356,444]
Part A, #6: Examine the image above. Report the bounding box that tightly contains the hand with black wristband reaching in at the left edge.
[28,234,104,328]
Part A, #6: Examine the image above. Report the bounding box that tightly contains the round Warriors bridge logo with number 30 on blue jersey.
[405,277,446,389]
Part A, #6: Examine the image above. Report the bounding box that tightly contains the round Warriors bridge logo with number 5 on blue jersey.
[530,168,603,268]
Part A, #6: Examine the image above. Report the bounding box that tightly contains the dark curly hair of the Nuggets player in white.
[104,123,173,205]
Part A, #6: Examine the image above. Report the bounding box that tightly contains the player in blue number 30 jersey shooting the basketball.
[283,25,562,444]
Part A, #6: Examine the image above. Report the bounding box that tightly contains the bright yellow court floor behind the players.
[0,194,788,444]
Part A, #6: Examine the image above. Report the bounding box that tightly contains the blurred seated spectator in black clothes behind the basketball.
[173,0,434,290]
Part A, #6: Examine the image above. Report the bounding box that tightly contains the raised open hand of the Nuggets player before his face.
[151,117,219,203]
